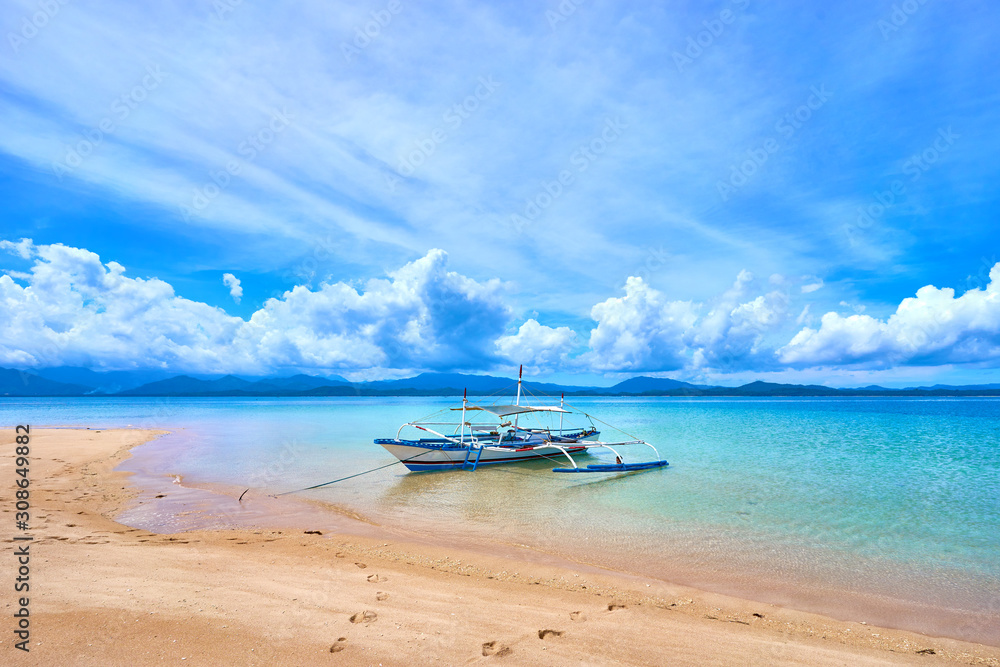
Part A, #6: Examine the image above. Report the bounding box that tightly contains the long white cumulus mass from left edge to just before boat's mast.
[0,244,511,373]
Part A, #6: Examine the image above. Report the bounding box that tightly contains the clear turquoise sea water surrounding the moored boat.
[7,397,1000,643]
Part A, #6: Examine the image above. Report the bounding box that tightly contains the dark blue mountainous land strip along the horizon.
[0,367,1000,397]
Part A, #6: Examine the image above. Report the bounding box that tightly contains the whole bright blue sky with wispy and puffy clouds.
[0,0,1000,386]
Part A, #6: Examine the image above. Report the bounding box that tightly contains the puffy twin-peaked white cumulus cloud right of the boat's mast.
[584,271,788,372]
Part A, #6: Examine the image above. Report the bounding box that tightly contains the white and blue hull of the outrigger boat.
[375,440,586,472]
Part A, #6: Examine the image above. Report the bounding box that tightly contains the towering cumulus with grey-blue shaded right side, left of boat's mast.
[245,250,511,369]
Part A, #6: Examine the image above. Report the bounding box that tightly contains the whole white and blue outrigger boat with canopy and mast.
[375,366,669,473]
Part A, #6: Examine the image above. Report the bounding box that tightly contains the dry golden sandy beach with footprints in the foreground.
[0,429,1000,665]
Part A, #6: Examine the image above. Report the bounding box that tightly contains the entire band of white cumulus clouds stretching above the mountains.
[0,239,1000,376]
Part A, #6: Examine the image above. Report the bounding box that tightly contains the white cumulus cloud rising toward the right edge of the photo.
[778,263,1000,368]
